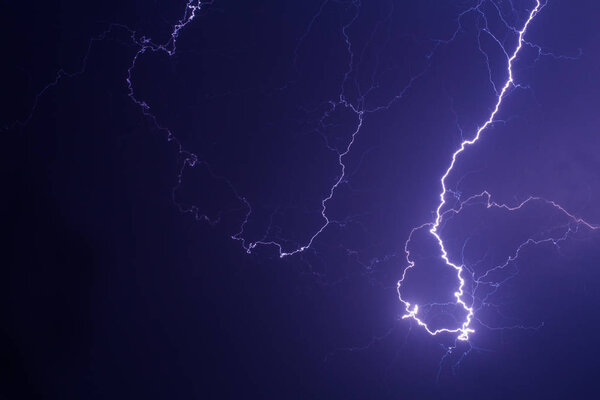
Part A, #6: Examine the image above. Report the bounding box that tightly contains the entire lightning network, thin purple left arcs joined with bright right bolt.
[6,0,600,354]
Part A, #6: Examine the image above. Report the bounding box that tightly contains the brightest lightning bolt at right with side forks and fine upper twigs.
[397,0,600,342]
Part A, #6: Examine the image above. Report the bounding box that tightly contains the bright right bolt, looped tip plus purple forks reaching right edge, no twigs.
[398,0,599,341]
